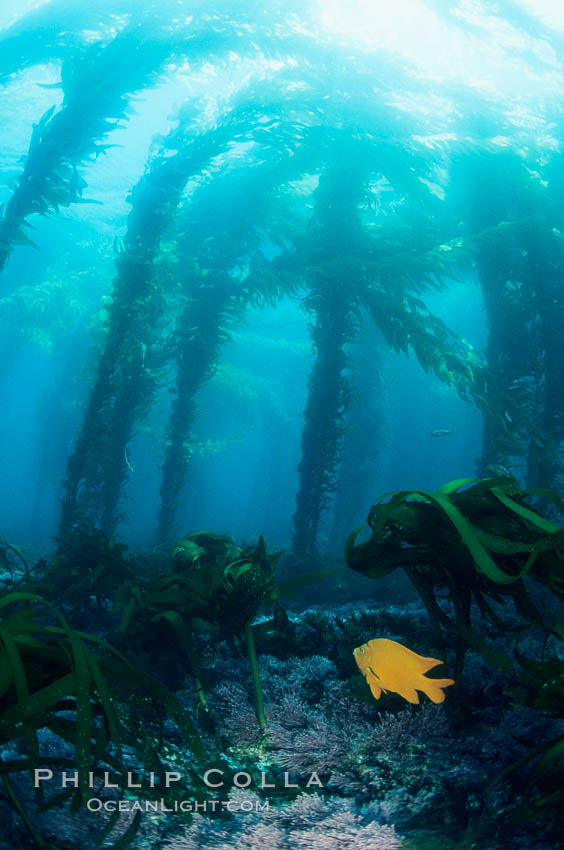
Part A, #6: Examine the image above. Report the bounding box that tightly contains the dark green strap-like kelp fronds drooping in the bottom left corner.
[0,592,205,846]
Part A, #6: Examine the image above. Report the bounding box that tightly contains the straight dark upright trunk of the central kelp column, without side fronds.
[293,167,362,556]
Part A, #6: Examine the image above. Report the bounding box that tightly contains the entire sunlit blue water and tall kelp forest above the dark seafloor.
[0,0,564,563]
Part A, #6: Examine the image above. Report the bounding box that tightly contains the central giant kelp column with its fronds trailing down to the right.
[248,74,498,553]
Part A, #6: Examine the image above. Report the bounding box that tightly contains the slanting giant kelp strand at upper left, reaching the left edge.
[0,28,176,270]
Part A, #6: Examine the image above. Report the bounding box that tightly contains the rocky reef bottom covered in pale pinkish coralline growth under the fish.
[0,602,564,850]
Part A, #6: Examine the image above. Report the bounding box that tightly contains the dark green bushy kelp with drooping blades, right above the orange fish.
[345,477,564,680]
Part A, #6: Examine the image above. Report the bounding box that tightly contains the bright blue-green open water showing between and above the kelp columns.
[0,2,540,551]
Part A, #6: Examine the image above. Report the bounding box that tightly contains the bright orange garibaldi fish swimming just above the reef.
[353,638,454,703]
